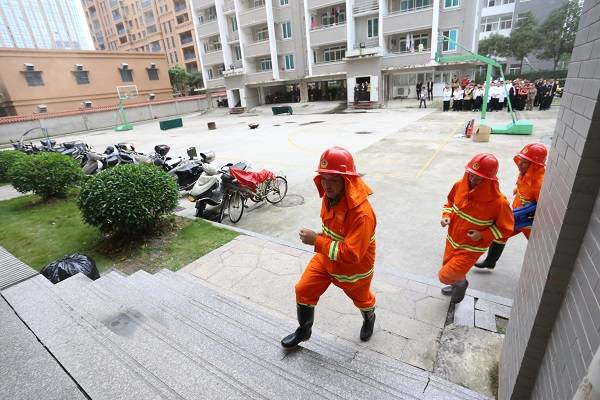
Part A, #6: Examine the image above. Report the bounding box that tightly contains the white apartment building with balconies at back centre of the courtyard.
[191,0,481,108]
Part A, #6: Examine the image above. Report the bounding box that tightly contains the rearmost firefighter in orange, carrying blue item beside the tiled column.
[475,143,548,269]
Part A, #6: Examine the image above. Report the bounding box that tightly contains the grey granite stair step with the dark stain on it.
[57,274,261,399]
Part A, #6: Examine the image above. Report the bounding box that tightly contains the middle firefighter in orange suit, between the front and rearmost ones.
[438,153,514,303]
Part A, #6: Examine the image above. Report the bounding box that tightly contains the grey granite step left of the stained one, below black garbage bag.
[2,275,173,400]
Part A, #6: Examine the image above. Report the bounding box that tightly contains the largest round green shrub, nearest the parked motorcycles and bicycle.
[78,164,179,234]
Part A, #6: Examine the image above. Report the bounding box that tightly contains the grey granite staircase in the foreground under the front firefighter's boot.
[0,270,486,400]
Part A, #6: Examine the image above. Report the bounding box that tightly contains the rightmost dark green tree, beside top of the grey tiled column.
[537,0,581,71]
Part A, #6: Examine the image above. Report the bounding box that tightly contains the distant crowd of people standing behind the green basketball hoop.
[438,75,559,111]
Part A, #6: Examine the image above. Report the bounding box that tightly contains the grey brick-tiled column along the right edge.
[499,0,600,400]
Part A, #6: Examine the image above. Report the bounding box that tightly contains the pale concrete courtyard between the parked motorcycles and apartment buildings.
[50,103,558,298]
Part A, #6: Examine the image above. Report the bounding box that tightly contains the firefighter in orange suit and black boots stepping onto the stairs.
[281,147,376,348]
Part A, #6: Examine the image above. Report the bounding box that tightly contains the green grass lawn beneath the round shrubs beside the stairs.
[0,192,237,273]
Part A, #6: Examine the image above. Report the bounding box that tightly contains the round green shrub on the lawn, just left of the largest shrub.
[8,153,84,200]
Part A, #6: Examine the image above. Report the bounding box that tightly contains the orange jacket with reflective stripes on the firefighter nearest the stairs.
[314,176,377,283]
